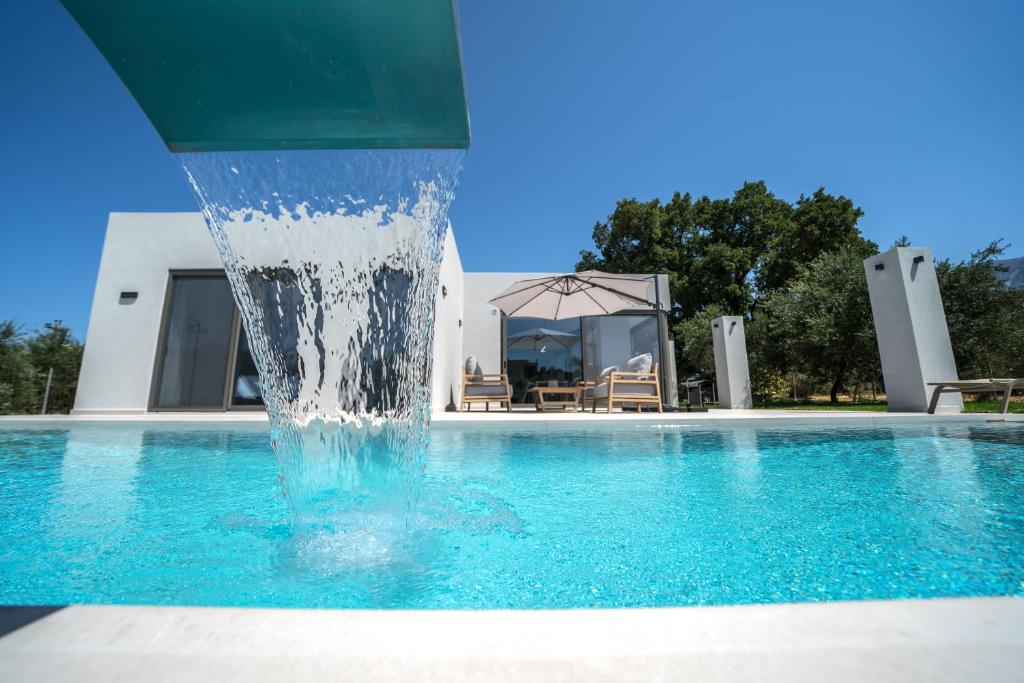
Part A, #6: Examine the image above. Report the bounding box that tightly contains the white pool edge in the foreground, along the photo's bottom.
[0,597,1024,683]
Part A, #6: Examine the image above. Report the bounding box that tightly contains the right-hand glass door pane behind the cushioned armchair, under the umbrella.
[583,315,662,380]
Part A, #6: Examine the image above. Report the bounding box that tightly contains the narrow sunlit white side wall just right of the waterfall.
[430,225,464,410]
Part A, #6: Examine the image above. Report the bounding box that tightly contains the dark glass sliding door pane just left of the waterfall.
[156,275,234,408]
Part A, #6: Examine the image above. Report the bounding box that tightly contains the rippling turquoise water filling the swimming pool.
[0,423,1024,608]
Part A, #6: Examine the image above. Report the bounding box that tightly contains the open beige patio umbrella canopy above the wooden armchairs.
[488,270,653,321]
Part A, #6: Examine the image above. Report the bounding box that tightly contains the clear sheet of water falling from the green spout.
[178,150,464,532]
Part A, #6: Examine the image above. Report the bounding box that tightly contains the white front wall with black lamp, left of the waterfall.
[75,213,223,413]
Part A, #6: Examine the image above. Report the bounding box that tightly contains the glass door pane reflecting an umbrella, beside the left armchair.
[505,317,583,402]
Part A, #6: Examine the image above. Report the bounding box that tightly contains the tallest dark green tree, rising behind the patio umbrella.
[577,181,874,374]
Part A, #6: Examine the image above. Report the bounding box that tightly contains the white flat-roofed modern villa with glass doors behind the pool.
[75,213,676,414]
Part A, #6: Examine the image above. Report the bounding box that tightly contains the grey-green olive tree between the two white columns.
[758,245,879,402]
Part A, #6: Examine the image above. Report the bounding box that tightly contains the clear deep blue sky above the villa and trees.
[0,0,1024,336]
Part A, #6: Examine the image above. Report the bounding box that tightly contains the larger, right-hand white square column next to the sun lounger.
[864,247,964,413]
